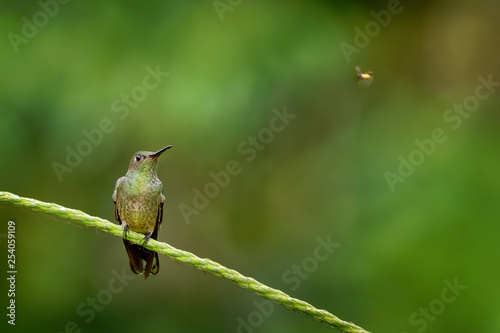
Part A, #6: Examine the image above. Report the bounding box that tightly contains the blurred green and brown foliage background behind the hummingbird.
[0,0,500,333]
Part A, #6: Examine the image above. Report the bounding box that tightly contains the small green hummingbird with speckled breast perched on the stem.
[113,145,172,279]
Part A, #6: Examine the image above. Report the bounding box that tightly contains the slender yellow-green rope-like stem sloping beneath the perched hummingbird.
[0,192,368,333]
